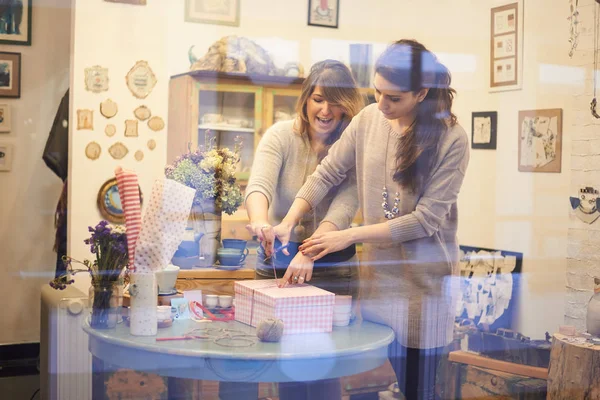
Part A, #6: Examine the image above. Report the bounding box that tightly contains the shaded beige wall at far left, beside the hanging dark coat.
[0,0,70,344]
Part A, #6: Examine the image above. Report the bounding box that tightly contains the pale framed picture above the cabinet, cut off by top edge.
[184,0,241,26]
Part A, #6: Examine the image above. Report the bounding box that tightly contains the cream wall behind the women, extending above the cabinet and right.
[163,0,582,338]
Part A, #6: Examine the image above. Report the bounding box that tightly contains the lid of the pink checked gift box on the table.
[254,284,335,308]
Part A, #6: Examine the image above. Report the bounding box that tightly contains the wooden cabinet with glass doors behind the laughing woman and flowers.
[167,71,303,240]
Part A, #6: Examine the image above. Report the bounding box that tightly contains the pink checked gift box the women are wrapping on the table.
[235,280,335,334]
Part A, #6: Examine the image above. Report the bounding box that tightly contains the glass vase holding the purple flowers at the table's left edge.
[89,283,123,329]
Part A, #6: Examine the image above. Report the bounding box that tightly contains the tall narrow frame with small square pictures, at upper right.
[489,0,524,92]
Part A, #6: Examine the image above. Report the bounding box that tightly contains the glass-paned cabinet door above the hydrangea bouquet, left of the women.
[197,83,262,185]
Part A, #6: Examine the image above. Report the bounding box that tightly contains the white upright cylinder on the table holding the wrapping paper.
[129,272,158,336]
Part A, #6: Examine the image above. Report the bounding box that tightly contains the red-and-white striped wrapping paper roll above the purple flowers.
[115,167,142,268]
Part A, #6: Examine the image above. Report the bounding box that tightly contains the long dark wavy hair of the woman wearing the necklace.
[375,39,457,193]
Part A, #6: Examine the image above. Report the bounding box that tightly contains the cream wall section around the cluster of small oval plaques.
[69,0,169,293]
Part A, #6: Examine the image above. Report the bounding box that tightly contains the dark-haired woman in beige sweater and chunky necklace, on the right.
[275,40,469,400]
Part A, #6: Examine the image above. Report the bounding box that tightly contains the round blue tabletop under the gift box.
[83,320,394,382]
